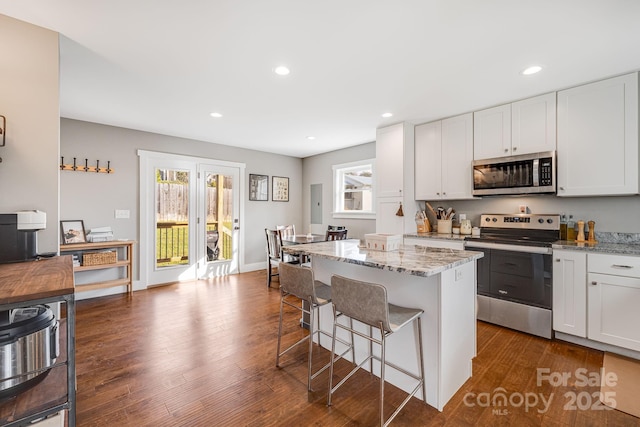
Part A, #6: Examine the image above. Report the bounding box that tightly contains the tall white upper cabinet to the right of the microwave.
[557,73,639,196]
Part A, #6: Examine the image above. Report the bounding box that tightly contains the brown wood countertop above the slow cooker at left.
[0,255,75,304]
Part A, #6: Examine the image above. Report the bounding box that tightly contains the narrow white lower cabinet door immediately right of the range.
[553,250,587,338]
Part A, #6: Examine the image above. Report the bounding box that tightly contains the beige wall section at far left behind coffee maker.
[0,15,60,252]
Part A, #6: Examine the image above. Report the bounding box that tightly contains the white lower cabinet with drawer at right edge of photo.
[587,254,640,351]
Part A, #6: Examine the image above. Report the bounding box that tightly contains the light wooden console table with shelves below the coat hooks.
[60,240,135,294]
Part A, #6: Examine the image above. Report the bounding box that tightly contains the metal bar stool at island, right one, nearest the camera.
[327,275,427,426]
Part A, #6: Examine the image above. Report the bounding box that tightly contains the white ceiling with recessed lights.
[0,0,640,157]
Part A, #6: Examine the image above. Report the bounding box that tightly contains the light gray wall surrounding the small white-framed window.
[302,142,376,239]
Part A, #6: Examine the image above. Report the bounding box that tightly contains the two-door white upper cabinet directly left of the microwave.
[415,113,473,200]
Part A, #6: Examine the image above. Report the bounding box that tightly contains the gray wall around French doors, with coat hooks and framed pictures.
[60,119,303,277]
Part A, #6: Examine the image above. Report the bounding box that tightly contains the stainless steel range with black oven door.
[465,214,560,338]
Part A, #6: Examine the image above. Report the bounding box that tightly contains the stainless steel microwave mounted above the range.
[473,151,556,196]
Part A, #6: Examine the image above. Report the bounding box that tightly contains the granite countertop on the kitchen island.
[282,239,484,277]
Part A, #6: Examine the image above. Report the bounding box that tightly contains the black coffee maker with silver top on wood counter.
[0,211,47,263]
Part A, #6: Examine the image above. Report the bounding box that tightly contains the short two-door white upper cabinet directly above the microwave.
[473,92,556,160]
